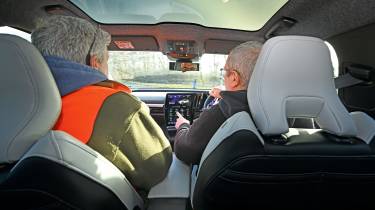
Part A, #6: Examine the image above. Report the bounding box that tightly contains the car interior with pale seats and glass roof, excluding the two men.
[0,0,375,210]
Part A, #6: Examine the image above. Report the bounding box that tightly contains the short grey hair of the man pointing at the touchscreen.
[225,41,263,89]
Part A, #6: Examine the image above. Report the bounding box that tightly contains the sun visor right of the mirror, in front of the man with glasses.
[204,39,242,54]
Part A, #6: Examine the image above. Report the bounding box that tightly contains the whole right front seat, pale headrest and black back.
[191,36,375,210]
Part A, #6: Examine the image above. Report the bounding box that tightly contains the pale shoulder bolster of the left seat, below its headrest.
[16,131,144,209]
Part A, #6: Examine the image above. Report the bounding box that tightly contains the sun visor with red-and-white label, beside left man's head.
[108,36,159,51]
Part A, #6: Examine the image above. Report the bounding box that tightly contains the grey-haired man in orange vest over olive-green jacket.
[31,16,172,191]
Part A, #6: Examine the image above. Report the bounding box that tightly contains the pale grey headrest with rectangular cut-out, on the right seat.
[248,36,357,136]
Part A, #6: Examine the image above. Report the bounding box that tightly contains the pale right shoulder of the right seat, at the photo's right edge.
[350,112,375,144]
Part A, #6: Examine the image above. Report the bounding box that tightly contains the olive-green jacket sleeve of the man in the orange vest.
[88,92,172,190]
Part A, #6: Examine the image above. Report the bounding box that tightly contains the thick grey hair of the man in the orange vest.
[31,15,111,64]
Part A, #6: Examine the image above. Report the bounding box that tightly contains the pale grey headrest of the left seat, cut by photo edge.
[0,34,61,163]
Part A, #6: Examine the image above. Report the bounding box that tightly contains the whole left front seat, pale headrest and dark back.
[0,34,144,210]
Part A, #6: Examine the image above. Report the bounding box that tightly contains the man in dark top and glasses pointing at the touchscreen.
[174,41,262,164]
